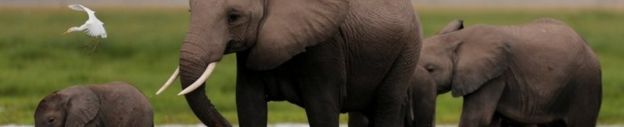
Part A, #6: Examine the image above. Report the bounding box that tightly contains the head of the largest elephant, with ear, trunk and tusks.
[158,0,348,125]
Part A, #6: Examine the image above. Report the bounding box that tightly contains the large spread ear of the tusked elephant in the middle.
[246,0,349,70]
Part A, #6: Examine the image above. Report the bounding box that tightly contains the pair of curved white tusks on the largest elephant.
[156,62,217,95]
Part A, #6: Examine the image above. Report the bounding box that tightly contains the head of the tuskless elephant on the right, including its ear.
[418,20,510,97]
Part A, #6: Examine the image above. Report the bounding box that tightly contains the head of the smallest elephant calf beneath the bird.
[35,86,100,127]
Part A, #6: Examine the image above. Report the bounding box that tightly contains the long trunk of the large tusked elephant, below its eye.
[179,28,231,127]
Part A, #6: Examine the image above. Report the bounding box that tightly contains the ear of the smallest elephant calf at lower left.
[63,86,100,127]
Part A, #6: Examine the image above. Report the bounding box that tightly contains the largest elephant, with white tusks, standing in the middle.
[156,0,421,127]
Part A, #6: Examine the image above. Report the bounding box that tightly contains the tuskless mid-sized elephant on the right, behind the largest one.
[419,19,602,127]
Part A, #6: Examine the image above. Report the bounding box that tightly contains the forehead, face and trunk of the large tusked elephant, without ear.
[161,0,231,124]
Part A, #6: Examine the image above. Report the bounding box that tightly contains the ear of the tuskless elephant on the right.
[451,32,511,97]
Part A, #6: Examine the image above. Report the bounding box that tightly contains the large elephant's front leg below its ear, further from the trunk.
[292,38,347,127]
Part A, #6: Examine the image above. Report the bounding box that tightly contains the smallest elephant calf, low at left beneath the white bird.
[35,82,154,127]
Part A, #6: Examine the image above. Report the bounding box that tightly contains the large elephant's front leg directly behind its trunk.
[236,54,267,127]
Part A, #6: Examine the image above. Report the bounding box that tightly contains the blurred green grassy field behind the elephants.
[0,8,624,125]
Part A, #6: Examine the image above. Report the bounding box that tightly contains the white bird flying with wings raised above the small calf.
[65,4,106,38]
